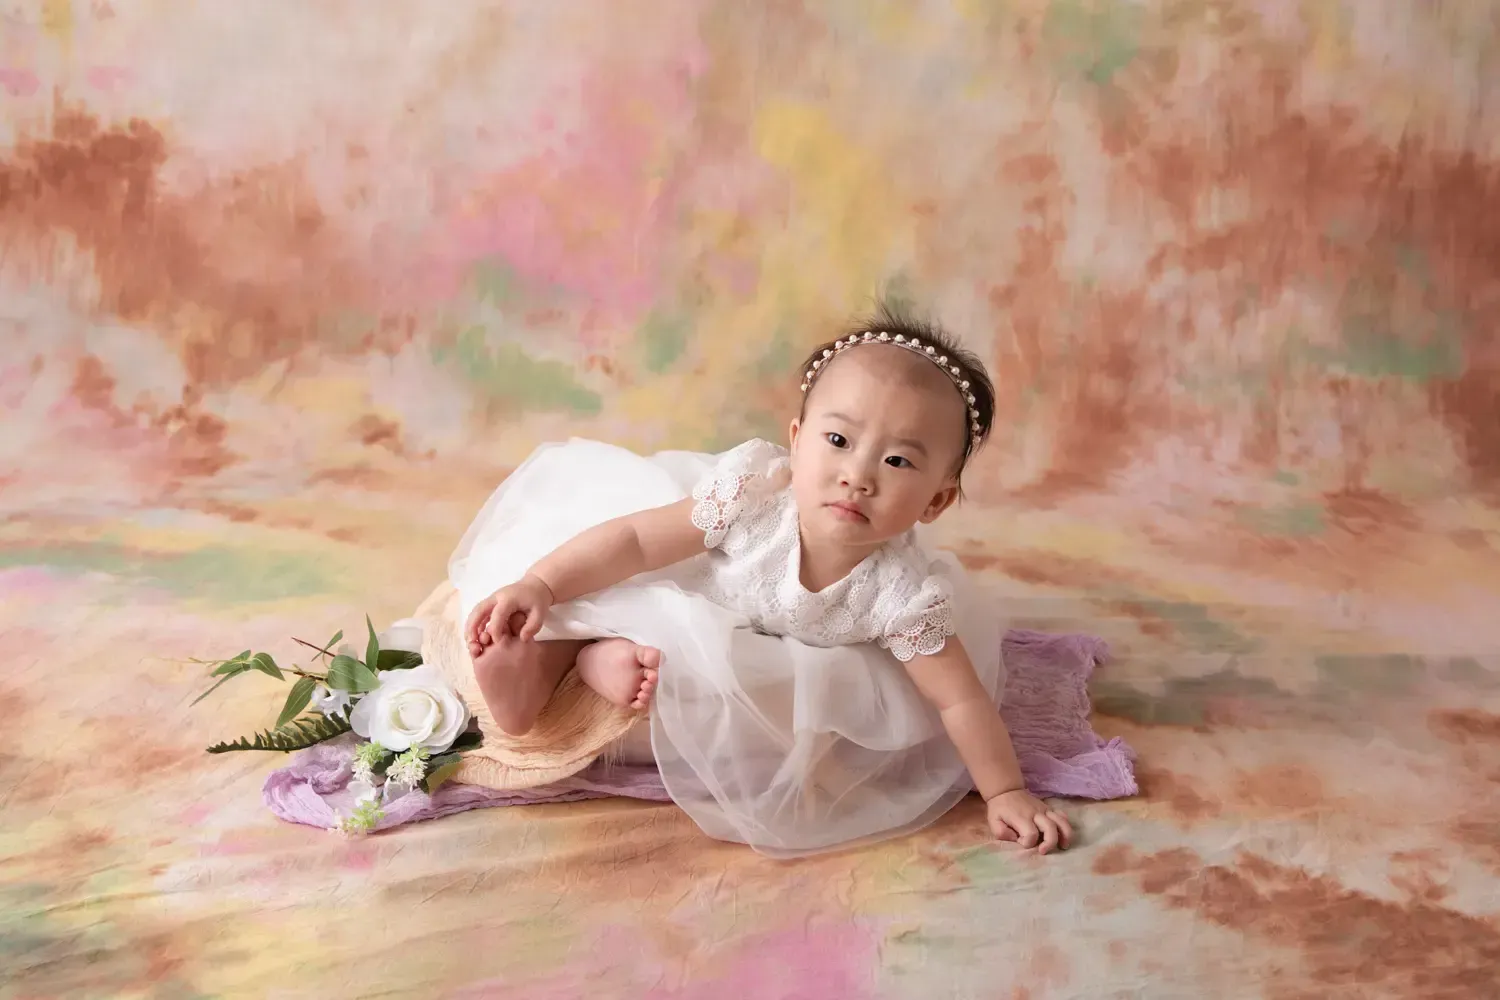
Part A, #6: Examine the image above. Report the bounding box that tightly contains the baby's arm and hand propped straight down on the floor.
[906,636,1073,853]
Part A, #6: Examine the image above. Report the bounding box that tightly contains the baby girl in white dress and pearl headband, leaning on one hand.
[450,309,1073,856]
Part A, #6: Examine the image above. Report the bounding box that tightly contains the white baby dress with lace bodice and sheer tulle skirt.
[449,439,1005,858]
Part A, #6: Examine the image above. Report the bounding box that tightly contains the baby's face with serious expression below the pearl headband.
[791,345,968,549]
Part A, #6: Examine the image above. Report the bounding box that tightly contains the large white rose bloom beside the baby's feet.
[350,666,470,754]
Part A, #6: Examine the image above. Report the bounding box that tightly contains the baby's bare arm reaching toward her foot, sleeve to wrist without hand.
[528,498,705,604]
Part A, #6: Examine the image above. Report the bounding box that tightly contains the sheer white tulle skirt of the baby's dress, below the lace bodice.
[449,439,1004,858]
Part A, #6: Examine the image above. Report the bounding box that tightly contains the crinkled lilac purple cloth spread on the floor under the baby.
[263,630,1137,829]
